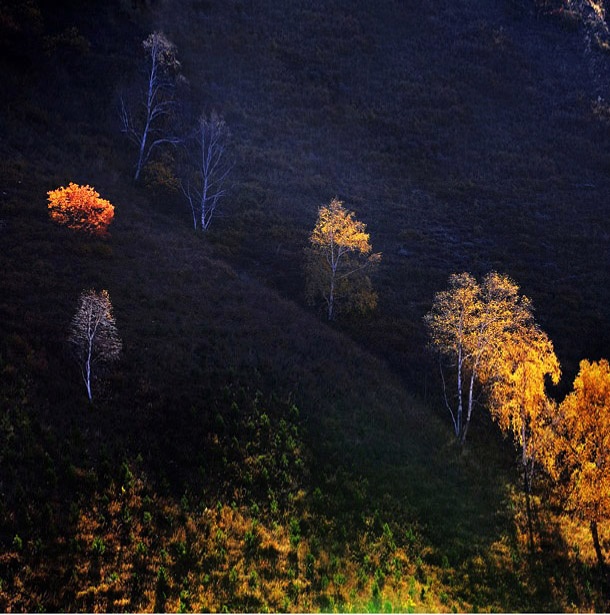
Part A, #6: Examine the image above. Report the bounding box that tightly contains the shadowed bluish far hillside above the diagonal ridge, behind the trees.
[153,0,610,387]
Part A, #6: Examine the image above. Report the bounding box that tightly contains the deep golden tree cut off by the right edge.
[549,359,610,567]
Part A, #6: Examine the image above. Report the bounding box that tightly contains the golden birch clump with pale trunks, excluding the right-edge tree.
[424,271,559,446]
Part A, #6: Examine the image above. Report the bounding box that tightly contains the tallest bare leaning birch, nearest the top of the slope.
[120,32,180,181]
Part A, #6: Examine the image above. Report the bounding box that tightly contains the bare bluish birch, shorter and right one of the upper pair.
[180,113,232,231]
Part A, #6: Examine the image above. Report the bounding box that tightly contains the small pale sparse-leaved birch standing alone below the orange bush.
[68,290,123,400]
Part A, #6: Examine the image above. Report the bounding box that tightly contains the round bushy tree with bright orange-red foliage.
[47,182,114,235]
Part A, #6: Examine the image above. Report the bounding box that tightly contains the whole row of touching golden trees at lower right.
[425,272,610,567]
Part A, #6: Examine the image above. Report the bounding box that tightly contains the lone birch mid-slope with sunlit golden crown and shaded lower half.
[306,198,381,320]
